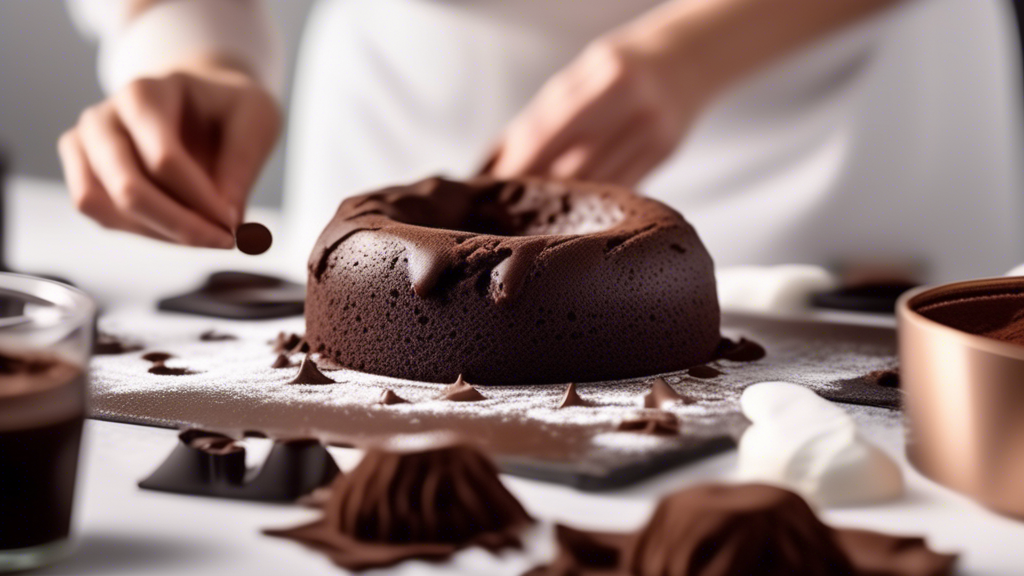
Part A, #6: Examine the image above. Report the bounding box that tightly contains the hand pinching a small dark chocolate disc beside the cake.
[57,68,281,248]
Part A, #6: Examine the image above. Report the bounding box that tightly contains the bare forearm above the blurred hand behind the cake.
[614,0,906,98]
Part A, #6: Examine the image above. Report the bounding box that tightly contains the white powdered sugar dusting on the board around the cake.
[90,307,899,467]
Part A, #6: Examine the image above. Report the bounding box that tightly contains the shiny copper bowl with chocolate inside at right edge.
[897,278,1024,519]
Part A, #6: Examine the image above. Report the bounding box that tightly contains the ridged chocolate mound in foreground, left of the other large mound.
[265,438,532,571]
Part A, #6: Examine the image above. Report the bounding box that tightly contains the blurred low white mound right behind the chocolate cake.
[715,264,839,313]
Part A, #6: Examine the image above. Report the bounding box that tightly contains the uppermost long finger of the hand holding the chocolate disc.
[113,76,239,231]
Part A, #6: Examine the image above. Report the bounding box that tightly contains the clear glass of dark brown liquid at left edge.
[0,274,95,572]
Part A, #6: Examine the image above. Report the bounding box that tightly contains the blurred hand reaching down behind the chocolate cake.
[489,33,706,186]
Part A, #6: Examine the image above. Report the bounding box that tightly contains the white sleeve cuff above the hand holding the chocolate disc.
[68,0,284,96]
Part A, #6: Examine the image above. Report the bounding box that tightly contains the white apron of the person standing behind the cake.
[283,0,1024,281]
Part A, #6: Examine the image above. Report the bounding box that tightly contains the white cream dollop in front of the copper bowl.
[737,382,903,507]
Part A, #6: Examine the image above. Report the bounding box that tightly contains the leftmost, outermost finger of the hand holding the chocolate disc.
[57,129,169,241]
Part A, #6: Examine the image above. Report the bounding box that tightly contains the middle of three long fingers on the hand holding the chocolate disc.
[79,105,234,248]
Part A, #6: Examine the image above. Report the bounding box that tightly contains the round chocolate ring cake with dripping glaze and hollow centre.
[305,178,720,384]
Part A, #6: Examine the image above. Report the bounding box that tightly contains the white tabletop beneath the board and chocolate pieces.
[3,178,1024,576]
